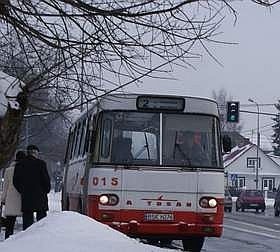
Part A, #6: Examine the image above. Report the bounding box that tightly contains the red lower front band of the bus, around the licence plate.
[87,196,224,237]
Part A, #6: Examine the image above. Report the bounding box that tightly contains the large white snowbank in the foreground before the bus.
[0,193,174,252]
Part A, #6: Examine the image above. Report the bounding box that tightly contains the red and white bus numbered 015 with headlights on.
[62,94,230,251]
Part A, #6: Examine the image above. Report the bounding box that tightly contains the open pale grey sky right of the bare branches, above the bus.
[126,1,280,146]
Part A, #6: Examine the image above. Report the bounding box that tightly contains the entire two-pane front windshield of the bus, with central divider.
[99,111,221,167]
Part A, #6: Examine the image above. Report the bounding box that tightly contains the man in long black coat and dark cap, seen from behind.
[13,145,51,230]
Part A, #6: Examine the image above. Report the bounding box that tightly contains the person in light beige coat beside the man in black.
[1,151,25,239]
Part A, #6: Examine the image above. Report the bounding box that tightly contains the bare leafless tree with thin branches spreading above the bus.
[0,0,278,167]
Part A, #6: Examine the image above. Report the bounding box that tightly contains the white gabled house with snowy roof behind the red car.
[223,142,280,191]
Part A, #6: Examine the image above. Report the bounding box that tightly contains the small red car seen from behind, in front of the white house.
[236,190,265,212]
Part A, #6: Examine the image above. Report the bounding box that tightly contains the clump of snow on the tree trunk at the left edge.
[0,71,25,118]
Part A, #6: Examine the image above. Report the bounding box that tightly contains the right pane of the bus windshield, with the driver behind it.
[162,114,221,167]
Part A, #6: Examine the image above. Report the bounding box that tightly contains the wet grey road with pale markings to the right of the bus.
[199,207,280,252]
